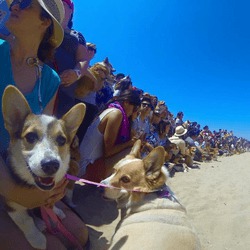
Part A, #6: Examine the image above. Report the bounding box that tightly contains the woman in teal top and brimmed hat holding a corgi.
[0,0,88,250]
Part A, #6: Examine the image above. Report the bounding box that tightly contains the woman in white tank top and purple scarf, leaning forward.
[79,89,140,182]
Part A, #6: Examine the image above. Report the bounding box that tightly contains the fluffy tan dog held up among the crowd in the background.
[75,58,114,98]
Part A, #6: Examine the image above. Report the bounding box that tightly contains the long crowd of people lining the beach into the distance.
[0,0,250,249]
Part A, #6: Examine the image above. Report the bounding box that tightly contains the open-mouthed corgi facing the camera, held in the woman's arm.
[2,85,85,249]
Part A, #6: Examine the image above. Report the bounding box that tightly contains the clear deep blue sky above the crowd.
[74,0,250,139]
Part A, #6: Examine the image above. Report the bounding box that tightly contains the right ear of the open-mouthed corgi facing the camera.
[61,103,86,142]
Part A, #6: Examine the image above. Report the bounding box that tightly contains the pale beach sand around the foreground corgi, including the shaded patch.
[74,152,250,250]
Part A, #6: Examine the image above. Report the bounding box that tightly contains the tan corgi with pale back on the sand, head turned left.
[102,140,201,250]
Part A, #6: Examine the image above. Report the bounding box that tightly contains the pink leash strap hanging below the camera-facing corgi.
[41,206,83,250]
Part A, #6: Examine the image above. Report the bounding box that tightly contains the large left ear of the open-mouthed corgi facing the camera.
[2,85,32,135]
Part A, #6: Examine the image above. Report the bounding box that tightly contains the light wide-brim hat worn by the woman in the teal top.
[7,0,65,47]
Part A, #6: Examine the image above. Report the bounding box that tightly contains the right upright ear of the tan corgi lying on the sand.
[143,146,165,180]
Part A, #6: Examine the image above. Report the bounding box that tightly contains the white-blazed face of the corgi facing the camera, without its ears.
[10,115,71,190]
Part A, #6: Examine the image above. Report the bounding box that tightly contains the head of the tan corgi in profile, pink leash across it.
[102,140,167,201]
